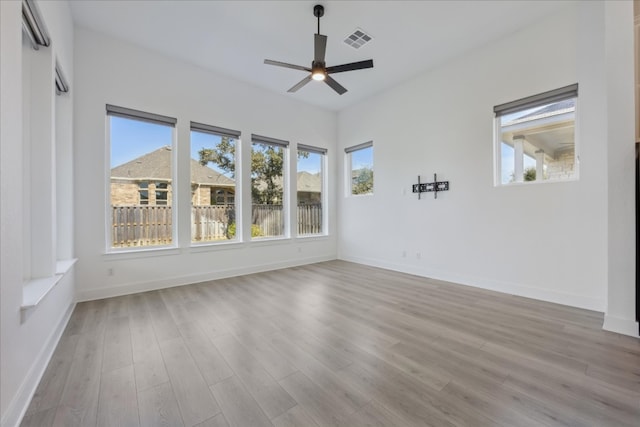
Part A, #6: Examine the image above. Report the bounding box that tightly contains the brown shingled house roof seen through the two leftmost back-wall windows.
[111,147,235,187]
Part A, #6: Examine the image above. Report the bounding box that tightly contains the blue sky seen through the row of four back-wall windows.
[109,116,322,176]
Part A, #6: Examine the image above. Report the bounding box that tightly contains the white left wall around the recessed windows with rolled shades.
[0,1,74,426]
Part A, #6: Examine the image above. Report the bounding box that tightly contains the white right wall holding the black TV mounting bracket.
[337,2,637,333]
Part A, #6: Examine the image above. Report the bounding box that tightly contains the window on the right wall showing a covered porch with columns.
[493,84,578,185]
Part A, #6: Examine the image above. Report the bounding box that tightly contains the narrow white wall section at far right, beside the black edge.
[604,2,640,336]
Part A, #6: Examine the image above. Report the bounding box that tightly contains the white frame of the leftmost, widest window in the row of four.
[104,104,178,254]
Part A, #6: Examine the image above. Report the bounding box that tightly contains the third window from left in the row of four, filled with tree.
[251,135,289,239]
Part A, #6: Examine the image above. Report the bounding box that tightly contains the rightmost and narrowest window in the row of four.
[296,144,327,236]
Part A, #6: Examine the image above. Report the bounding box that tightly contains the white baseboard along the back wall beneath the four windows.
[76,255,336,302]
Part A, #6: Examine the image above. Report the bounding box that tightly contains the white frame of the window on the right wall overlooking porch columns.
[493,83,580,187]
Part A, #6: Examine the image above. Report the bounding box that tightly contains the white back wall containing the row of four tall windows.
[75,29,337,300]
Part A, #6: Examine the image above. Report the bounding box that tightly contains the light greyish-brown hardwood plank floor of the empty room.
[22,261,640,427]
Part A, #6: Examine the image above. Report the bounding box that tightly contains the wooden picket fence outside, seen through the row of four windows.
[111,204,322,248]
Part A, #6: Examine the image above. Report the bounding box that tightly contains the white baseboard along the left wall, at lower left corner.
[0,302,76,427]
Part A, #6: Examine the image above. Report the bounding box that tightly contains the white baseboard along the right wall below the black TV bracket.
[338,255,605,312]
